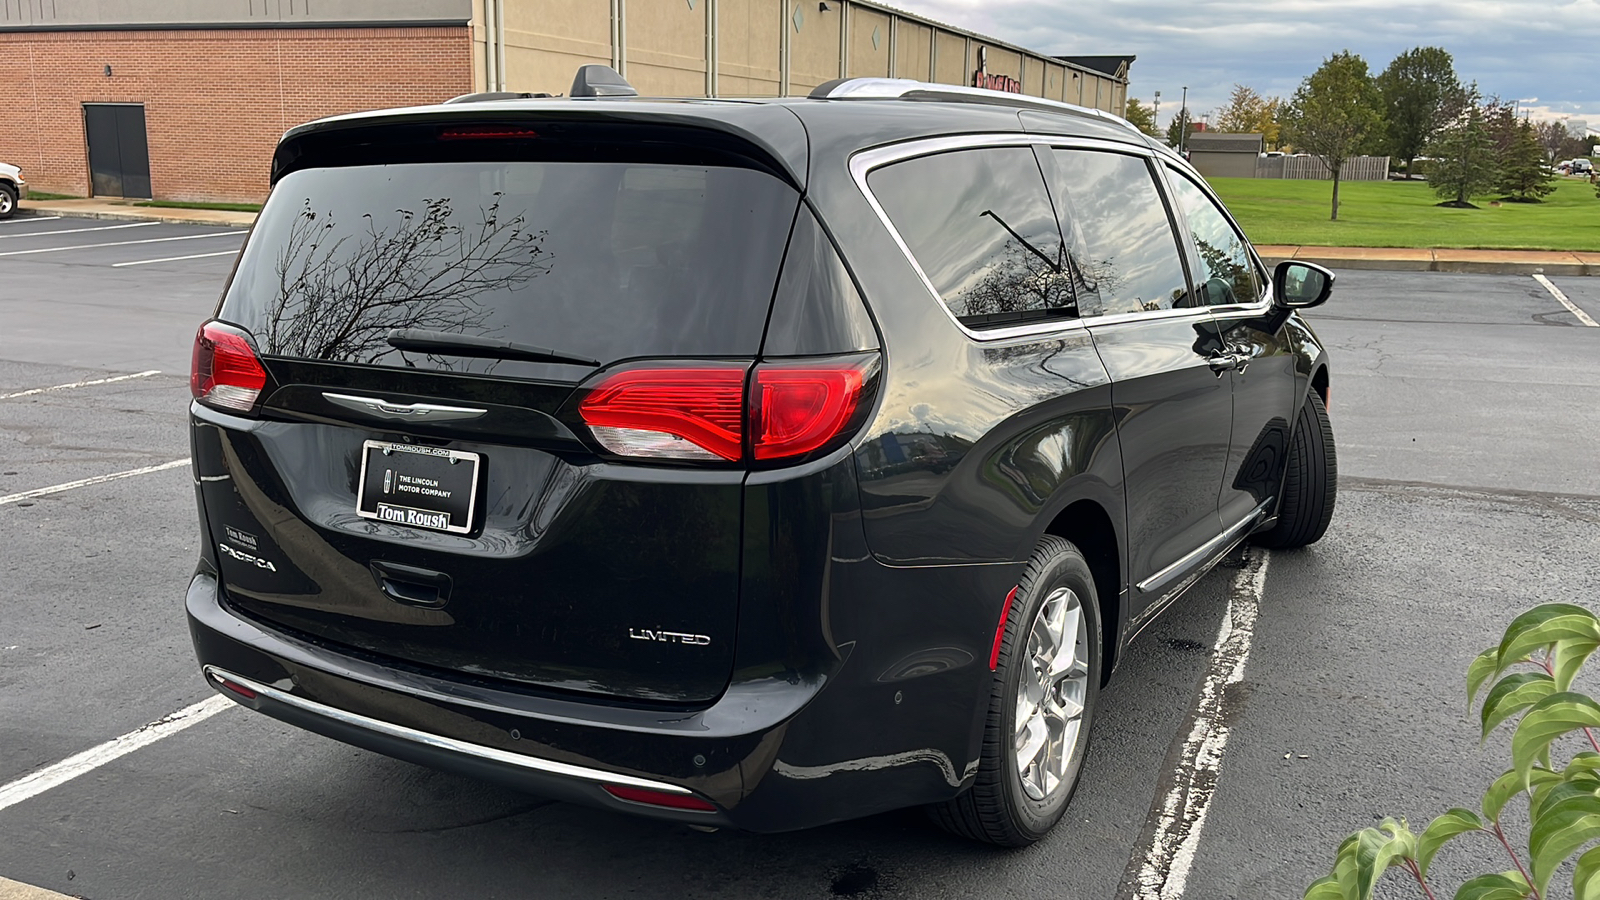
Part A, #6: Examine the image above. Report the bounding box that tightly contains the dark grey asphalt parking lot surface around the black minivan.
[0,218,1600,900]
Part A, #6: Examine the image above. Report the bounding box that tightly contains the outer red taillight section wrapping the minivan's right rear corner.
[750,360,867,460]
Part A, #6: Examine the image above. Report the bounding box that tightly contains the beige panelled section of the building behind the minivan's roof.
[472,0,1133,114]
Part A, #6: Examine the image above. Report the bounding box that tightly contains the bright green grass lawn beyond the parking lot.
[1211,178,1600,251]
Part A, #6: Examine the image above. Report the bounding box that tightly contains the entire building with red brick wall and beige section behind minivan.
[0,0,1131,200]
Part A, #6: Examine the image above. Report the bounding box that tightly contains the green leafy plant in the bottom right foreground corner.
[1306,604,1600,900]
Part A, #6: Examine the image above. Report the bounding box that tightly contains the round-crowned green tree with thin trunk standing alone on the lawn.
[1283,50,1382,221]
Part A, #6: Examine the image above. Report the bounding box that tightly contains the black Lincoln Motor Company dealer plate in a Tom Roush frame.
[355,440,478,535]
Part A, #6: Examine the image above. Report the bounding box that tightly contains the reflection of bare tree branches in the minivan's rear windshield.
[266,194,552,365]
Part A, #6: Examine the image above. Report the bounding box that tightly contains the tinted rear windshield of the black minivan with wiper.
[219,162,798,375]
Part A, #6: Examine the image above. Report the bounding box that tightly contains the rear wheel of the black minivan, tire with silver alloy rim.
[928,535,1104,847]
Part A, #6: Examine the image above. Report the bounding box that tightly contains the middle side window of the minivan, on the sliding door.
[1051,149,1190,317]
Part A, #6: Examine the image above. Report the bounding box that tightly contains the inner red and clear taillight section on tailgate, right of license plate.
[578,364,746,461]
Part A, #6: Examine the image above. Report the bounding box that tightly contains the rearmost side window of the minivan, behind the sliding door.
[869,147,1077,328]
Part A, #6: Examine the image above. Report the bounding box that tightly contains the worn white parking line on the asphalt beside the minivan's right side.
[1118,548,1270,900]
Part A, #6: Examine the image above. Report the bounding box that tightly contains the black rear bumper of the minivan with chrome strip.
[186,563,1011,831]
